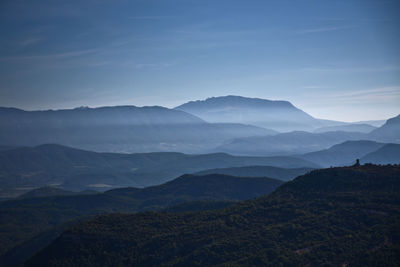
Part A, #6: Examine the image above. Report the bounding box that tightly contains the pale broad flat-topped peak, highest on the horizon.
[175,95,343,132]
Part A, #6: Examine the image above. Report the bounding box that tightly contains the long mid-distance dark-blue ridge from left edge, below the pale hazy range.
[0,145,318,197]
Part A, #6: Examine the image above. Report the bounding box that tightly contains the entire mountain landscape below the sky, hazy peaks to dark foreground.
[0,96,400,266]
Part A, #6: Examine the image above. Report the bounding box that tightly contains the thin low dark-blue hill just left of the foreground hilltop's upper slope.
[196,166,312,181]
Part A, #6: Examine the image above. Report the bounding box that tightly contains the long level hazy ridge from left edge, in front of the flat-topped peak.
[0,106,275,153]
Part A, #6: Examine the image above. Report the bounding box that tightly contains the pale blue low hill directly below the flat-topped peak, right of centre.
[215,132,366,156]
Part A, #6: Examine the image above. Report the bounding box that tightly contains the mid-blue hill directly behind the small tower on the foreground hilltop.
[299,140,385,167]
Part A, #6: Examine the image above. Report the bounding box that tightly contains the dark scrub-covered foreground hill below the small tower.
[26,164,400,266]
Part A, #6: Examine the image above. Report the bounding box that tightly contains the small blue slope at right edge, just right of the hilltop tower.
[360,144,400,164]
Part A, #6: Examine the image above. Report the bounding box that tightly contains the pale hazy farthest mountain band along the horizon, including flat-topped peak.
[0,96,400,156]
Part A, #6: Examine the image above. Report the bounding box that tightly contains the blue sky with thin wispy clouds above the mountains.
[0,0,400,121]
